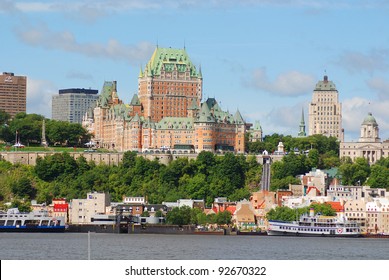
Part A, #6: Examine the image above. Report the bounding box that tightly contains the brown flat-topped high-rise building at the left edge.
[0,72,27,118]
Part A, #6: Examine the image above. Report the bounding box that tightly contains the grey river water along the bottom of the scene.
[0,233,389,260]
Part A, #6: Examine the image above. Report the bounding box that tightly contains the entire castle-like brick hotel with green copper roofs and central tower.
[83,48,249,153]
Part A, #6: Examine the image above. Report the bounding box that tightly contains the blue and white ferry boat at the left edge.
[0,208,65,232]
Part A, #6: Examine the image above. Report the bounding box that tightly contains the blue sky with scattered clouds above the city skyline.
[0,0,389,141]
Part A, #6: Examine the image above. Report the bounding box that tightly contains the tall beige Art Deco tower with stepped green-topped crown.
[309,76,343,141]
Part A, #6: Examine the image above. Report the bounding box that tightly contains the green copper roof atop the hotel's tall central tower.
[140,47,201,78]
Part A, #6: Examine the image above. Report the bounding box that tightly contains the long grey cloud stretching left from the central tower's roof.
[16,24,155,65]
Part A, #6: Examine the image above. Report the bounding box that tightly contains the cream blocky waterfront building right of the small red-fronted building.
[69,192,111,224]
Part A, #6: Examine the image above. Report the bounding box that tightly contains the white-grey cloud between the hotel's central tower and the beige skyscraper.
[245,67,315,97]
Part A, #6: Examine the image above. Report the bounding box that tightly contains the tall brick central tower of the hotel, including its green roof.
[138,47,203,121]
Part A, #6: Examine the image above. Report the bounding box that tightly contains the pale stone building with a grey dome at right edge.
[339,112,389,164]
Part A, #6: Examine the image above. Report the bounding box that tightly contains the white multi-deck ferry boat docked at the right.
[267,210,362,237]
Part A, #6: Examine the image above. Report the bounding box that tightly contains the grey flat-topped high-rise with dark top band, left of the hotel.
[51,88,98,123]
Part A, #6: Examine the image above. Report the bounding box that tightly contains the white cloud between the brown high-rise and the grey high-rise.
[27,78,58,118]
